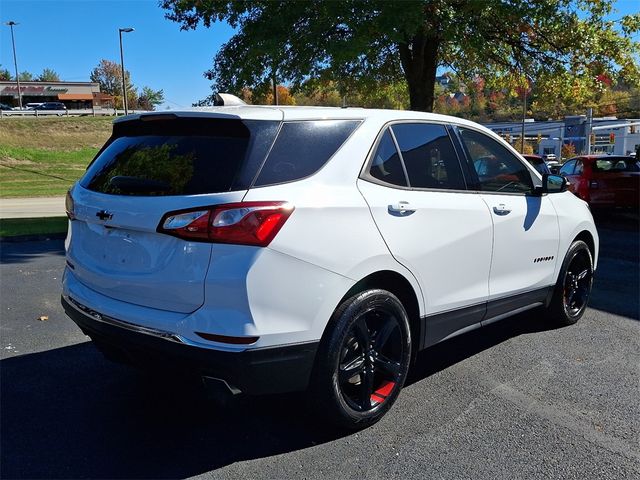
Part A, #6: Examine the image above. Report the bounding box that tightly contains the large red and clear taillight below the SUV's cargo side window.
[157,202,293,247]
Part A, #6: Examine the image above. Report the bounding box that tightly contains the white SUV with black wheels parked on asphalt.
[62,106,598,428]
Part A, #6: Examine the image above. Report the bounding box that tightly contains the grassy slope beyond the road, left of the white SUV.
[0,117,113,198]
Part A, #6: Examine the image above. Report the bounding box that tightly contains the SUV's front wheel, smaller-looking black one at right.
[547,240,593,326]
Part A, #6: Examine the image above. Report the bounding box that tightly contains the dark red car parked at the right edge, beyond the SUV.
[560,155,640,209]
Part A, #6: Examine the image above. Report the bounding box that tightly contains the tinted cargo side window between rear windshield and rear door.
[255,120,360,187]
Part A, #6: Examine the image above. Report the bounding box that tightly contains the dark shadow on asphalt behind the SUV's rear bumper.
[0,343,344,478]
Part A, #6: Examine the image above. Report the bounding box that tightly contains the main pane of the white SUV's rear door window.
[391,123,465,190]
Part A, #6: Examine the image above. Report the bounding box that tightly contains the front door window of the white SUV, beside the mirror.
[459,128,533,193]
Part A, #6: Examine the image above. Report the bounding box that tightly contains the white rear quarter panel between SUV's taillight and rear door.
[244,116,424,314]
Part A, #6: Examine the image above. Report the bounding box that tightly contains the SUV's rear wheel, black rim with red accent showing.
[311,289,411,429]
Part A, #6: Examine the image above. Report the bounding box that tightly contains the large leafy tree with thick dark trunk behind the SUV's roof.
[160,0,640,111]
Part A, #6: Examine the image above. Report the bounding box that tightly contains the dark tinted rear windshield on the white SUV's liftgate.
[80,118,279,196]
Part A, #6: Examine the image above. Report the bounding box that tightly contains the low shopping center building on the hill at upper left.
[0,81,113,110]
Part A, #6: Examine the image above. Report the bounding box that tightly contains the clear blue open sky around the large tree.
[0,0,640,110]
